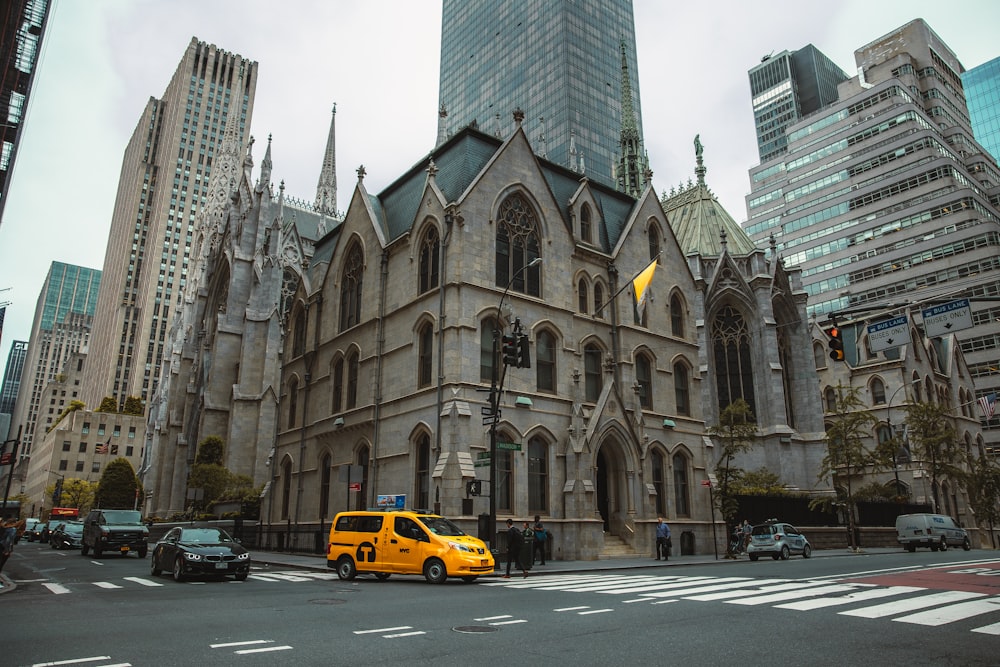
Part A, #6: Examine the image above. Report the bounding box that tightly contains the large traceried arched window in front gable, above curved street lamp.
[496,194,542,296]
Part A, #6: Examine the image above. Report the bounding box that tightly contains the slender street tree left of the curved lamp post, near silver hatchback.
[819,383,883,550]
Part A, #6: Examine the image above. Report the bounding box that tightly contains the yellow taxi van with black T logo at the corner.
[326,510,494,584]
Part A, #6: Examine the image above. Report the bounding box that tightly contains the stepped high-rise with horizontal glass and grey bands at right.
[745,19,1000,447]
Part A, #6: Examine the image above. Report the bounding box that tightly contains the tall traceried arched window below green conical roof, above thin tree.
[712,306,757,415]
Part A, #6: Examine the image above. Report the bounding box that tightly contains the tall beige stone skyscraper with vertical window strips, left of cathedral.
[84,38,257,409]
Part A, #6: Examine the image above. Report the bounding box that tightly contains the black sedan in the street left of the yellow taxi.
[149,527,250,581]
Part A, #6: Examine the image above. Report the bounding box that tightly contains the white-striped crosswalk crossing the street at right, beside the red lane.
[480,574,1000,635]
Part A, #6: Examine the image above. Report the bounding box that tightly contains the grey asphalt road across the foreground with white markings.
[0,543,1000,667]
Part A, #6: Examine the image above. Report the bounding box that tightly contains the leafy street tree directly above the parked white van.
[905,403,963,512]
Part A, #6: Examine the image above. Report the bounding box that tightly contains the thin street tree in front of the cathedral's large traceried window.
[708,398,757,558]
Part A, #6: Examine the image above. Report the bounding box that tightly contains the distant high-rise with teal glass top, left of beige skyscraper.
[11,262,101,456]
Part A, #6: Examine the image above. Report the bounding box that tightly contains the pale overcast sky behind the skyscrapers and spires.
[0,0,1000,378]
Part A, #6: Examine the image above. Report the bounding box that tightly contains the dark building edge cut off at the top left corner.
[0,0,49,230]
